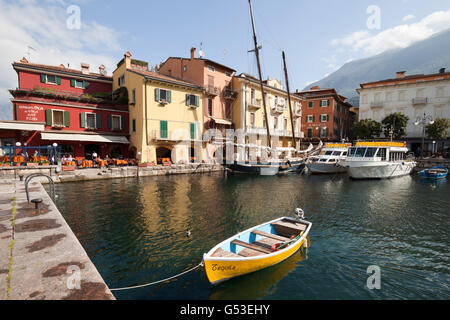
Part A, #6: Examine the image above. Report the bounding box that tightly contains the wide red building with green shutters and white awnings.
[6,58,129,158]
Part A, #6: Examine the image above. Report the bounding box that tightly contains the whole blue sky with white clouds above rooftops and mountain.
[0,0,450,119]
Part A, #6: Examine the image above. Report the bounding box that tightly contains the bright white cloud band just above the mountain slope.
[330,10,450,57]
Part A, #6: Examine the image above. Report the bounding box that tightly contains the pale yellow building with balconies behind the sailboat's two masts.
[233,73,303,160]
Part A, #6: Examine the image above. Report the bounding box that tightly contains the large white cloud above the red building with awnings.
[0,0,123,118]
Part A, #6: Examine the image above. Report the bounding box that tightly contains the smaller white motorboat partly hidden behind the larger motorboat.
[306,143,352,174]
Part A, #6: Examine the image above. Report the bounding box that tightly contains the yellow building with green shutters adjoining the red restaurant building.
[113,52,204,163]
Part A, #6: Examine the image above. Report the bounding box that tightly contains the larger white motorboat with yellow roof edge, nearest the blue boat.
[343,141,416,179]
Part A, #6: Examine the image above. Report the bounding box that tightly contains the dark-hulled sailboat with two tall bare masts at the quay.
[228,0,305,175]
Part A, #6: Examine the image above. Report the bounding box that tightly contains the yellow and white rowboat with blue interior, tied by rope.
[203,209,312,284]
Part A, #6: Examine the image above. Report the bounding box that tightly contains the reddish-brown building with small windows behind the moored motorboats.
[295,86,354,142]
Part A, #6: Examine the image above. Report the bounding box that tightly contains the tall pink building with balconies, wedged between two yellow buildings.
[159,48,237,141]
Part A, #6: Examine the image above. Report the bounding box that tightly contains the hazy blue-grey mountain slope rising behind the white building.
[304,29,450,105]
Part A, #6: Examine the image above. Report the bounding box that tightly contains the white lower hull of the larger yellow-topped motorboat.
[348,161,416,179]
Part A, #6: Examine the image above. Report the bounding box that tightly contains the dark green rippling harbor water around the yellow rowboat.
[46,173,450,300]
